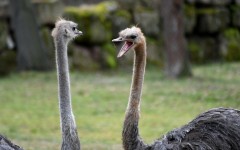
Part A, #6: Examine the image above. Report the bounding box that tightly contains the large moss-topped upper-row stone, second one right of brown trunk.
[197,8,230,33]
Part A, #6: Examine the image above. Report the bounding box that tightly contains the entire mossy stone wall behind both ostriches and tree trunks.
[0,0,240,72]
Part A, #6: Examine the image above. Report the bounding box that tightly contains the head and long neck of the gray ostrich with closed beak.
[52,19,82,150]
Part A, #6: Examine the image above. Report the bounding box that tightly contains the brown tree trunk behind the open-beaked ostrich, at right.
[161,0,191,78]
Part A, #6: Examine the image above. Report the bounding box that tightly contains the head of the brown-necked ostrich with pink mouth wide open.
[112,26,145,57]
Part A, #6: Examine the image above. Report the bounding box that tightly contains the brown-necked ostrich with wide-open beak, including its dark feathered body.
[112,26,240,150]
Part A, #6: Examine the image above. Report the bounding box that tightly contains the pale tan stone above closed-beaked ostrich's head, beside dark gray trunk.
[33,0,64,25]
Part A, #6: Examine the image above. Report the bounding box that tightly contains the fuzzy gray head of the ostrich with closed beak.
[52,19,82,42]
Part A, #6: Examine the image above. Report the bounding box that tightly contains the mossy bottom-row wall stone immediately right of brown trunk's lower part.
[187,37,219,63]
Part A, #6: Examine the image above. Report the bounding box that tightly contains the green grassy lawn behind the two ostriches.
[0,63,240,150]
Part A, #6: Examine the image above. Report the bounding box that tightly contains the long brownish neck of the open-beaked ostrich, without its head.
[122,42,146,150]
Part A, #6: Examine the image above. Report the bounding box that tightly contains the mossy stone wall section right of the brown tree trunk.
[185,0,240,63]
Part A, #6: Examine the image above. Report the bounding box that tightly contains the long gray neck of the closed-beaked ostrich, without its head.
[55,36,80,150]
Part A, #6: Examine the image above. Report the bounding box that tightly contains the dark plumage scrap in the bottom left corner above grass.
[0,135,23,150]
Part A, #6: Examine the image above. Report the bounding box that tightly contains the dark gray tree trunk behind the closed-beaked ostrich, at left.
[10,0,50,70]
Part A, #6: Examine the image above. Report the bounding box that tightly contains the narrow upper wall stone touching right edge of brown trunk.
[184,5,196,33]
